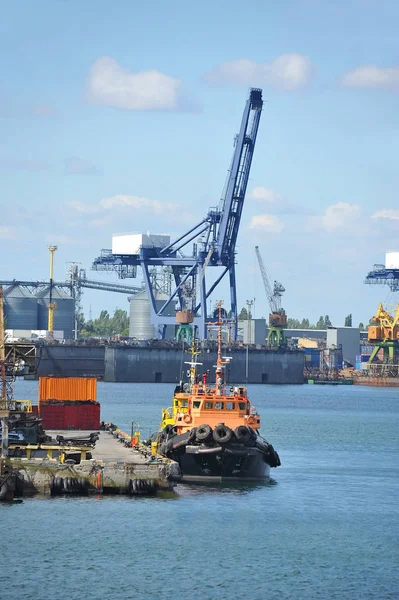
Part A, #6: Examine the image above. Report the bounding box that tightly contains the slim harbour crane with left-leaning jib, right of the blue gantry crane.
[255,246,287,347]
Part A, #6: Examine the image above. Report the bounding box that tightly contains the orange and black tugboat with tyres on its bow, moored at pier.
[151,302,281,481]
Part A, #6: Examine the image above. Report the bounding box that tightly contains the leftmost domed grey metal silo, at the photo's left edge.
[4,285,37,331]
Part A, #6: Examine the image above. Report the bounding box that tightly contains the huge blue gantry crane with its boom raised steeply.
[92,88,263,339]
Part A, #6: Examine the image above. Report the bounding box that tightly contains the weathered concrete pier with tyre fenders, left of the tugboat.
[0,429,181,497]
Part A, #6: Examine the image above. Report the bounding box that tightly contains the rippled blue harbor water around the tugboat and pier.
[0,382,399,600]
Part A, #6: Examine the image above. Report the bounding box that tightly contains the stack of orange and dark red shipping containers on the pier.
[39,377,100,430]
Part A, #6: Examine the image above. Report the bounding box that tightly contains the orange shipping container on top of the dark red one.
[39,377,97,404]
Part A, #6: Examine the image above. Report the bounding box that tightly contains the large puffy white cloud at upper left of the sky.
[87,56,187,110]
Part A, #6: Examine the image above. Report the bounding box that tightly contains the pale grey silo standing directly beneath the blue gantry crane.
[128,289,176,340]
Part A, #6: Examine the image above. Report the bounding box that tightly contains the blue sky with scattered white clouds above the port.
[0,0,399,325]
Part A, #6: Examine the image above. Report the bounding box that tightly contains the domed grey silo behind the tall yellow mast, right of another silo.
[37,286,75,340]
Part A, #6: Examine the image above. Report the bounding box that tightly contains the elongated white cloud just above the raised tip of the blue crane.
[205,54,313,91]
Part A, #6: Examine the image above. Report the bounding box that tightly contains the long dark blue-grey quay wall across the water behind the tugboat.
[36,344,305,384]
